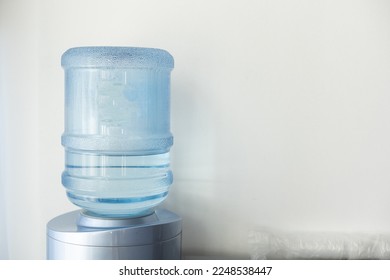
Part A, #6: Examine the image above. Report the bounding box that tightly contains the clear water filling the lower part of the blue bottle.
[62,151,172,216]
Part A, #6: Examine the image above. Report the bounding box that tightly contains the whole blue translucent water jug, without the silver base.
[61,47,173,217]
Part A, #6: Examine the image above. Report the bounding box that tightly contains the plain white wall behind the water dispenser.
[0,0,390,259]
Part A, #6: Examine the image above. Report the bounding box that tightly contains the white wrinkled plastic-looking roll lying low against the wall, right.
[249,230,390,260]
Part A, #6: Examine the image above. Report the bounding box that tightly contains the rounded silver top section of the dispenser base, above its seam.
[47,209,181,247]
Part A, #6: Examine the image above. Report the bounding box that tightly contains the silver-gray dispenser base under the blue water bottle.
[47,210,181,260]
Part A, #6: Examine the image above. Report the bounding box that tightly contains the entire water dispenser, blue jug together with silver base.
[47,47,181,259]
